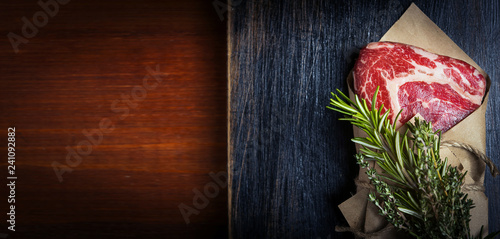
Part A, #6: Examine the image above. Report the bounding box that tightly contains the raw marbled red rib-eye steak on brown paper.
[353,42,486,132]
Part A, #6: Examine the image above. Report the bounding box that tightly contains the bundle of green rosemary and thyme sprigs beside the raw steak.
[327,88,500,238]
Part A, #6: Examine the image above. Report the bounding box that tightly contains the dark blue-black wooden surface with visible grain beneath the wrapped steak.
[228,0,500,238]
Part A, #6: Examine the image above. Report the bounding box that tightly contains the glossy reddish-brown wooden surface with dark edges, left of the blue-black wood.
[0,0,227,238]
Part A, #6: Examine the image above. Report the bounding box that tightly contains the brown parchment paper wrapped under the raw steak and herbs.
[339,3,491,238]
